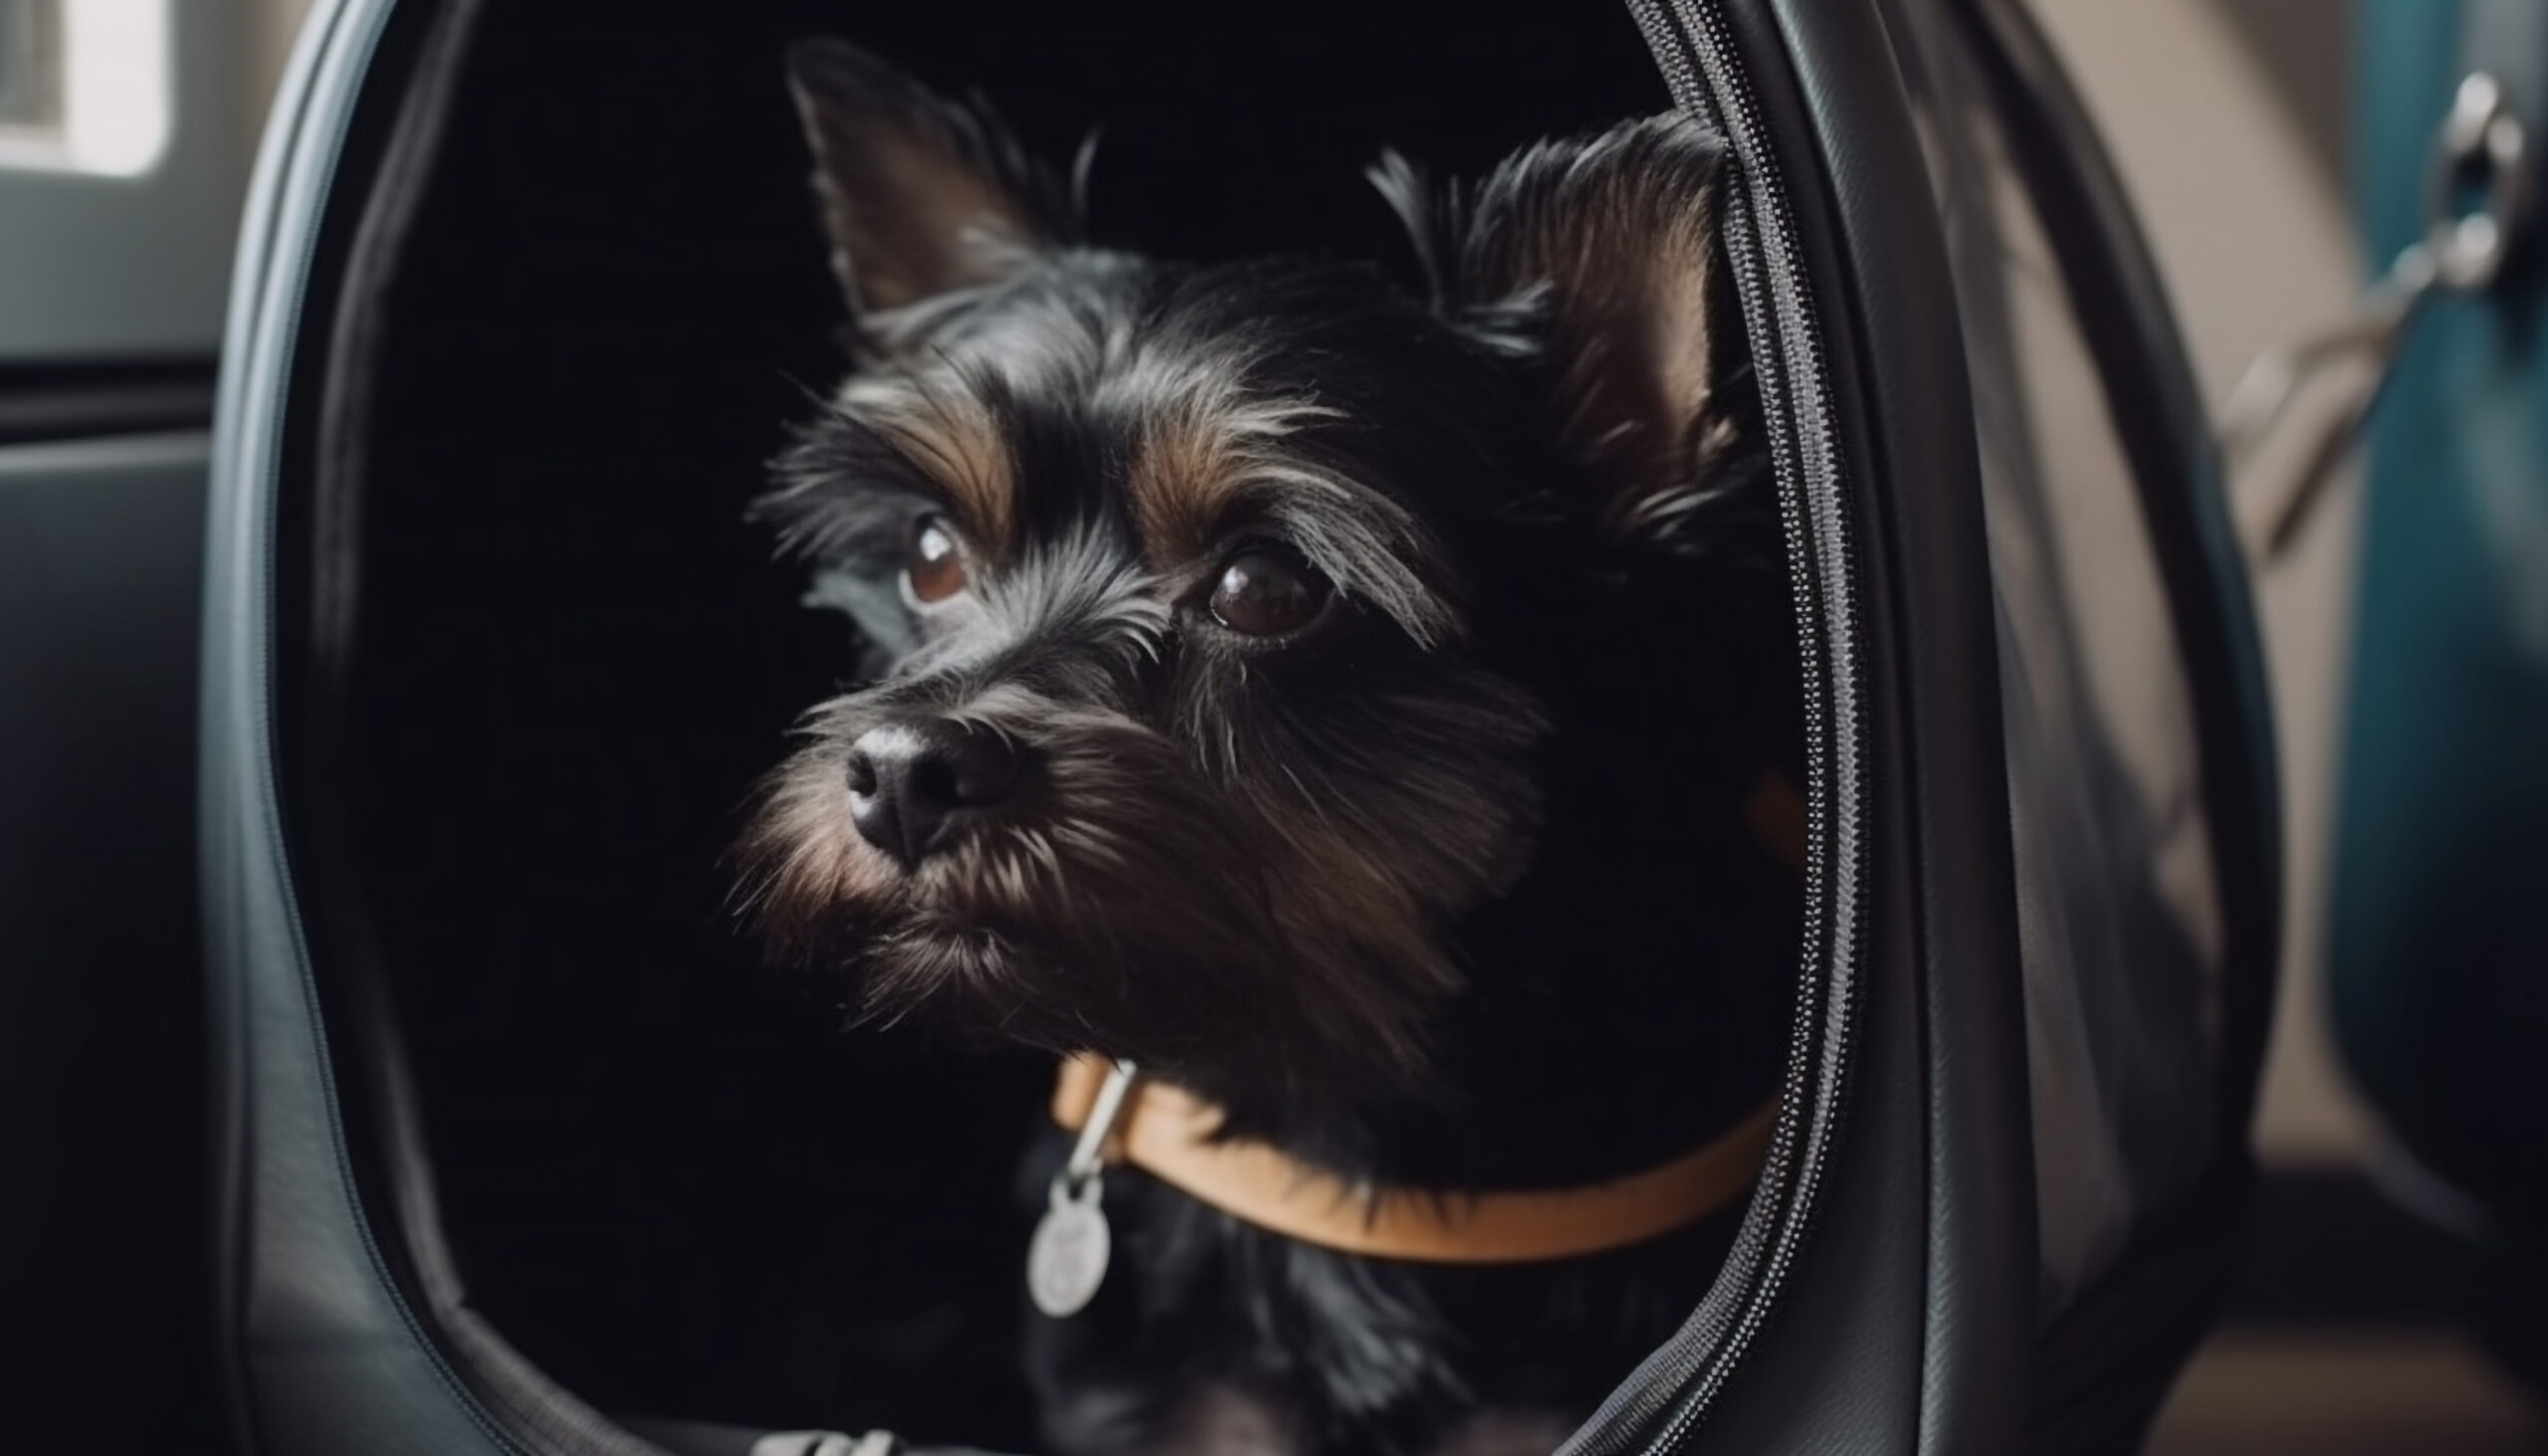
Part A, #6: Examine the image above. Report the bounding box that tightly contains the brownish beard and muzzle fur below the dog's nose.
[742,686,1532,1086]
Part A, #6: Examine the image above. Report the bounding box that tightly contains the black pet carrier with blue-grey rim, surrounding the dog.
[204,0,2278,1456]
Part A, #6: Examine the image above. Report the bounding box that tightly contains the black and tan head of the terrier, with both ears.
[744,44,1761,1101]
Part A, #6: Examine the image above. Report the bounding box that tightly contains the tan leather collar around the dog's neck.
[1052,1053,1779,1265]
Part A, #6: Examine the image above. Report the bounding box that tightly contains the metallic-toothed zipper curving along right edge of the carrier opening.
[1570,0,1865,1456]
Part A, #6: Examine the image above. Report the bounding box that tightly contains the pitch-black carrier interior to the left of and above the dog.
[278,0,1753,1448]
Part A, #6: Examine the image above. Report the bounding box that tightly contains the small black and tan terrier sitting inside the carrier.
[742,41,1804,1456]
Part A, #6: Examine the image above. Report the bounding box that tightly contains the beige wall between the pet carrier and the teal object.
[2033,0,2370,1165]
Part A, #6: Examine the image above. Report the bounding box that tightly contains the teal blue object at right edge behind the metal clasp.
[2329,0,2548,1223]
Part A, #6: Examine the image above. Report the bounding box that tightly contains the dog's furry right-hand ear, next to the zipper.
[1457,114,1753,545]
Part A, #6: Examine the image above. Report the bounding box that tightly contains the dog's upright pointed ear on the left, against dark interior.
[787,41,1078,321]
